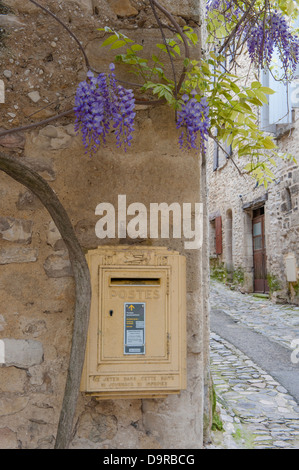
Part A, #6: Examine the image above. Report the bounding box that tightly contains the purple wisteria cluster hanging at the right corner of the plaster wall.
[177,90,210,151]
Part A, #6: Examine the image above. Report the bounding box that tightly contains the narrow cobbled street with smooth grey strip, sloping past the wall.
[210,281,299,449]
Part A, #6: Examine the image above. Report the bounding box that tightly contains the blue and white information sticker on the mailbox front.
[124,302,145,354]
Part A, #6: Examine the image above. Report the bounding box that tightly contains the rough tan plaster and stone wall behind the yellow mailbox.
[0,0,208,448]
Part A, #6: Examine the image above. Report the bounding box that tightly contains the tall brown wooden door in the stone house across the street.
[252,214,269,293]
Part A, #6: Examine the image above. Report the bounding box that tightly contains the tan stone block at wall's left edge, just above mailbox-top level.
[0,217,33,244]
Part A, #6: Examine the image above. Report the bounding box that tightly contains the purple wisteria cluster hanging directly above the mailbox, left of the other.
[74,64,136,155]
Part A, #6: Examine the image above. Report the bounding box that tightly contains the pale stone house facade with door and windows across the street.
[208,100,299,304]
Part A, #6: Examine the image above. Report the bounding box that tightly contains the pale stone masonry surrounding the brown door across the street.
[208,104,299,303]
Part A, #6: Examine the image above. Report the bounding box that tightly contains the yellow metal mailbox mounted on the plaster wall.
[81,245,186,399]
